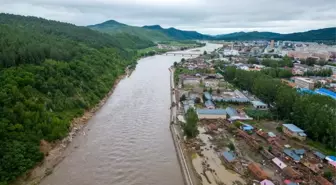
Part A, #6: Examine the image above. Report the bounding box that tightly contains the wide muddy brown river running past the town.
[40,44,220,185]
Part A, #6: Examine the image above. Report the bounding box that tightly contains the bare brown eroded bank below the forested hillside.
[11,67,133,185]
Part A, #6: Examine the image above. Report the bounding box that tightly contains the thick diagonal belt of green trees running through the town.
[224,67,336,149]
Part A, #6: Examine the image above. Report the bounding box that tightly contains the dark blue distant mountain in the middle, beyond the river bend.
[143,25,212,40]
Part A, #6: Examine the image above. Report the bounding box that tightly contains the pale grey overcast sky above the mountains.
[0,0,336,34]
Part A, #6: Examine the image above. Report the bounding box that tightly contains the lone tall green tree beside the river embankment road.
[183,108,199,138]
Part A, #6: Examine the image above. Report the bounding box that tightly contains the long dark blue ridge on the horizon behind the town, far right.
[214,28,336,41]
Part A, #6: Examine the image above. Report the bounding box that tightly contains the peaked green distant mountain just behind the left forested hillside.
[88,20,172,41]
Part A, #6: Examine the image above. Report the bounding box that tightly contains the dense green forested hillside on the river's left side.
[0,14,153,185]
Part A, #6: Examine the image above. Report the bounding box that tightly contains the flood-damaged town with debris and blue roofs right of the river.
[170,40,336,185]
